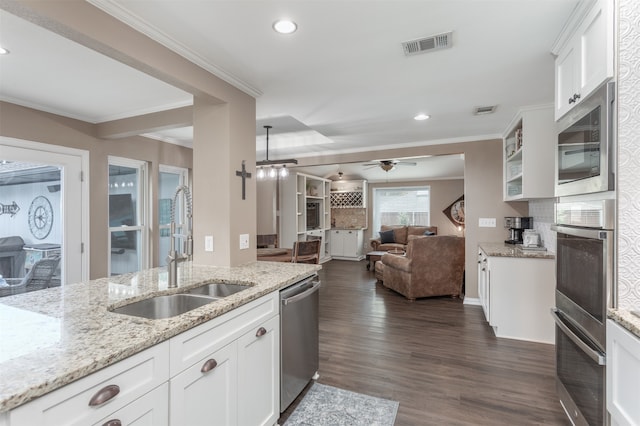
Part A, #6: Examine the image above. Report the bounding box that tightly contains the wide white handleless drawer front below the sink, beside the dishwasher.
[169,291,280,377]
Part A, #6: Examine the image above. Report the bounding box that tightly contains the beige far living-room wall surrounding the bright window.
[365,179,464,243]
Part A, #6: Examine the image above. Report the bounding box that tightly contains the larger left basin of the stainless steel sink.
[113,294,216,319]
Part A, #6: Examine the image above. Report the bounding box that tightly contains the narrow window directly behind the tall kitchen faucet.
[158,164,189,266]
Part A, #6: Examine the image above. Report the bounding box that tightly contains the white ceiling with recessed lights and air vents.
[0,0,578,179]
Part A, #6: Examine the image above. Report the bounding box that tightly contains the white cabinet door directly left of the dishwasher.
[238,315,280,426]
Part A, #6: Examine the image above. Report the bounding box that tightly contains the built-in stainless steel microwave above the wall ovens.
[555,82,616,197]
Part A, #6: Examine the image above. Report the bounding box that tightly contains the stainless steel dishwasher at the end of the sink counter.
[280,275,320,413]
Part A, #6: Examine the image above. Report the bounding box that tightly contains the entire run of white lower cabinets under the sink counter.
[6,291,280,426]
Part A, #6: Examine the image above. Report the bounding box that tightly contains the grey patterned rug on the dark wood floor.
[284,383,399,426]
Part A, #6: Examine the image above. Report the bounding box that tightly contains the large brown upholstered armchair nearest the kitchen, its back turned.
[381,235,464,300]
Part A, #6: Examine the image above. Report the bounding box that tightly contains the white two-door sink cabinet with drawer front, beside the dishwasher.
[169,292,280,425]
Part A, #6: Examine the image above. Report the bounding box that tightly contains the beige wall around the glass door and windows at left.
[0,102,192,279]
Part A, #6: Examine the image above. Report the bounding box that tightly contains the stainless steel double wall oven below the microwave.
[552,199,616,425]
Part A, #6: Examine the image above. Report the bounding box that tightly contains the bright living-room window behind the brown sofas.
[373,186,430,233]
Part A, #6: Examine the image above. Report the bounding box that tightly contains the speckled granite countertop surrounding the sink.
[0,262,320,413]
